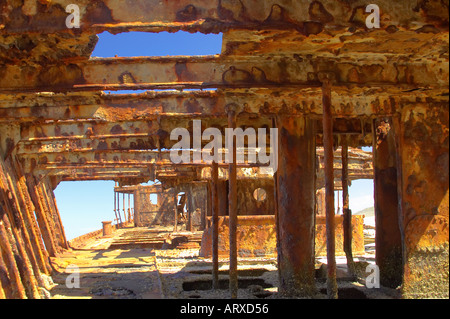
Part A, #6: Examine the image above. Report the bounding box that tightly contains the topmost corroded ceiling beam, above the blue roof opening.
[0,0,448,34]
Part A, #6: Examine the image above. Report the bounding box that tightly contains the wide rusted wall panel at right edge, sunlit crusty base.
[394,104,449,298]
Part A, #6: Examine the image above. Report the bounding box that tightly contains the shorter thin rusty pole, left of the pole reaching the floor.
[211,161,219,289]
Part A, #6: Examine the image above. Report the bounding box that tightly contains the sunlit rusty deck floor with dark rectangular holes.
[45,228,398,299]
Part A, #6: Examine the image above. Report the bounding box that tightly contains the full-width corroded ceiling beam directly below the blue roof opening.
[0,54,448,93]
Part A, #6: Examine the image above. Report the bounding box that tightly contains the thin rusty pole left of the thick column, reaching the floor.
[227,104,238,299]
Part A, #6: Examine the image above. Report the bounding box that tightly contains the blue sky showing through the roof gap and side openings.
[55,32,373,240]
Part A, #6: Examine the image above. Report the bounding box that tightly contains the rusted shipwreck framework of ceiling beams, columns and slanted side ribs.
[0,0,449,298]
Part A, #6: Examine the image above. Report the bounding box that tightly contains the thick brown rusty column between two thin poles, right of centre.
[276,115,316,297]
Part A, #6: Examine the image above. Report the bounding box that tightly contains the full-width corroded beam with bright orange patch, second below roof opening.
[0,87,448,123]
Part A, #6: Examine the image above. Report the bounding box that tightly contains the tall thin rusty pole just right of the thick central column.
[320,74,338,299]
